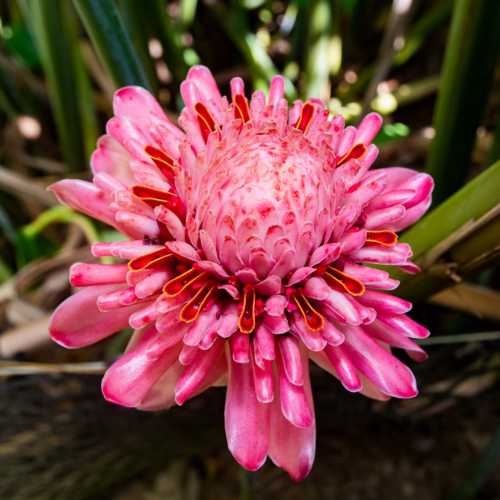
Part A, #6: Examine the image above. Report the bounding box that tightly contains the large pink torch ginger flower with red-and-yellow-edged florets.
[50,66,433,480]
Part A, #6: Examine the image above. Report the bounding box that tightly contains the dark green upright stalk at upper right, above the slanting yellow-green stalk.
[426,0,500,203]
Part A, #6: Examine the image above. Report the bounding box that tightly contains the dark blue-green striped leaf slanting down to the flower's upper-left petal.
[72,0,151,89]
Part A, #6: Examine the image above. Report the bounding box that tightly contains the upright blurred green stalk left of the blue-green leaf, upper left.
[29,0,96,170]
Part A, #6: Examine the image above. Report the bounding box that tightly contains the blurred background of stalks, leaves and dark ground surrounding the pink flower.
[0,0,500,500]
